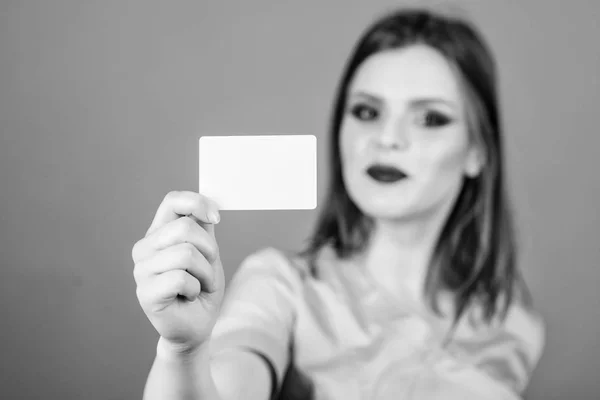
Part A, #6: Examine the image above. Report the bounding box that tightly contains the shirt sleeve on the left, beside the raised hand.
[211,248,301,392]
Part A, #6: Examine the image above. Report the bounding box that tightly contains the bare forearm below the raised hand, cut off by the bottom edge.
[143,341,222,400]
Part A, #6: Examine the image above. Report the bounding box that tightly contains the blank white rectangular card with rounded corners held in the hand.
[198,135,317,210]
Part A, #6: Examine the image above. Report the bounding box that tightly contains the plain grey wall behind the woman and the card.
[0,0,600,400]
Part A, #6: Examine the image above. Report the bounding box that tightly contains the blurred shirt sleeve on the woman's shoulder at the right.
[420,305,545,400]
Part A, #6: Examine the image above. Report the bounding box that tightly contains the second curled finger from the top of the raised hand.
[132,216,219,263]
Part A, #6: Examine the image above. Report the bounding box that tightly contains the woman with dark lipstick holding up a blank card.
[133,10,544,400]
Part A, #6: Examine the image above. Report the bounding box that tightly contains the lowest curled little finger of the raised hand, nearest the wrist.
[138,270,201,311]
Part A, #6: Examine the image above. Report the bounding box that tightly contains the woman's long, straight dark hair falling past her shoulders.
[300,8,529,324]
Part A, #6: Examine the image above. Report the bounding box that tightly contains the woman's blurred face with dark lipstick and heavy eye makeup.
[339,45,479,220]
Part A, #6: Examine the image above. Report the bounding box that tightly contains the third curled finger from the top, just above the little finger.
[133,243,217,293]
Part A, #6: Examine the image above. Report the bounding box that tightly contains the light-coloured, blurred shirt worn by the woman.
[211,247,545,400]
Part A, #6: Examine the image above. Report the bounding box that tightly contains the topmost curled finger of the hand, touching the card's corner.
[146,191,220,236]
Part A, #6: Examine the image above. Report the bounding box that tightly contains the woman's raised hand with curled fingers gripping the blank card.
[132,191,225,353]
